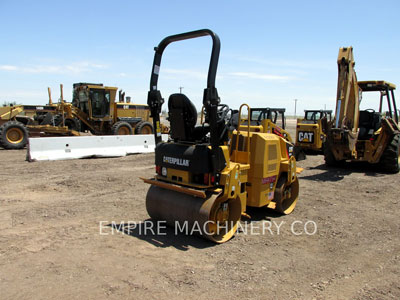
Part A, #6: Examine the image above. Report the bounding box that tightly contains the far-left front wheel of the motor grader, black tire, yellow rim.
[0,121,28,149]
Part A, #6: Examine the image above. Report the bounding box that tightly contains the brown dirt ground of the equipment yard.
[0,120,400,299]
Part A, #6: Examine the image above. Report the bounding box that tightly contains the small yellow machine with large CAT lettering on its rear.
[296,110,332,153]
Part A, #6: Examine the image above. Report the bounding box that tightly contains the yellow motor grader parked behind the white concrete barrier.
[0,83,156,149]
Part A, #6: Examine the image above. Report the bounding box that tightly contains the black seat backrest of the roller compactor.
[168,94,197,141]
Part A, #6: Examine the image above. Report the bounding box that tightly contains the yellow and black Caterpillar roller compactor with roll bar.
[142,29,299,243]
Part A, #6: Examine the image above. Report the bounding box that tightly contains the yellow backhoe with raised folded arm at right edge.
[324,47,400,173]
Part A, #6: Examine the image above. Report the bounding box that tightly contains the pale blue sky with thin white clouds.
[0,0,400,114]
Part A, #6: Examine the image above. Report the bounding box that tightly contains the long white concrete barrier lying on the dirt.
[27,134,168,162]
